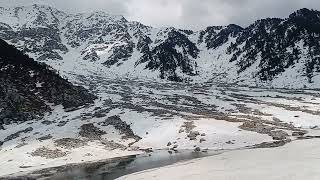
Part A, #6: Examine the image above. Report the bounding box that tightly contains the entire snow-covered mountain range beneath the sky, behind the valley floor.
[0,5,320,88]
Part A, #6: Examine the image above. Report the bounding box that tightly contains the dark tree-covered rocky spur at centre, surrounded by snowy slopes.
[140,30,199,81]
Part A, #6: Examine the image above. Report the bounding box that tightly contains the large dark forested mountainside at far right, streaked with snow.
[229,9,320,82]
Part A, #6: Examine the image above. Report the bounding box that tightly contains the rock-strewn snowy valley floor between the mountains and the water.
[0,76,320,177]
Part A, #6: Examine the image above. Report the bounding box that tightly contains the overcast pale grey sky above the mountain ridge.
[0,0,320,29]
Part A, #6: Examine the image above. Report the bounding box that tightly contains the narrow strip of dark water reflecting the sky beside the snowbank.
[42,151,221,180]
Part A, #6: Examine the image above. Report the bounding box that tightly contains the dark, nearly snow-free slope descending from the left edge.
[0,40,96,126]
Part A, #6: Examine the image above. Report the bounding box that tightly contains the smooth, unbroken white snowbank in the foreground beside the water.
[119,139,320,180]
